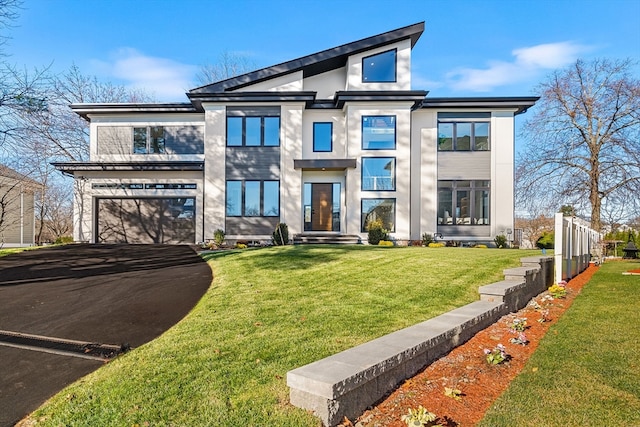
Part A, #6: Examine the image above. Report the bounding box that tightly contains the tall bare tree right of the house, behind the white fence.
[516,59,640,230]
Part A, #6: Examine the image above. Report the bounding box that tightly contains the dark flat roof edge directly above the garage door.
[51,162,204,175]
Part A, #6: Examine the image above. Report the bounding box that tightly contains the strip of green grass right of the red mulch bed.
[480,262,640,427]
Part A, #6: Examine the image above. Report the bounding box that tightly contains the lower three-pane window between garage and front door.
[227,181,280,216]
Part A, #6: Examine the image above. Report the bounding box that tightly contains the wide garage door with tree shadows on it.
[95,197,196,244]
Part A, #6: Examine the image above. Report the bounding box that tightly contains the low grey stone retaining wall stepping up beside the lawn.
[287,257,553,426]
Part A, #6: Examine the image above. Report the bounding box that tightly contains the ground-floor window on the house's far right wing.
[438,181,489,225]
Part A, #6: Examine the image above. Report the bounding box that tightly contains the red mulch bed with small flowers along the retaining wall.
[341,265,598,427]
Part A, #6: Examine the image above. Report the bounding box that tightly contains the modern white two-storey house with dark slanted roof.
[56,23,538,243]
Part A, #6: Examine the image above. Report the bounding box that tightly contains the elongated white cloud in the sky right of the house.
[446,42,592,92]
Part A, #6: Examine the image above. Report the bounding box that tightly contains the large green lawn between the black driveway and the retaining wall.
[33,246,539,427]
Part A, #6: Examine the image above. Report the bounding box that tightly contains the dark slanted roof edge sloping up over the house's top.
[187,21,424,96]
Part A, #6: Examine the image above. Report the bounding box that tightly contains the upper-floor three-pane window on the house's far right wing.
[438,122,489,151]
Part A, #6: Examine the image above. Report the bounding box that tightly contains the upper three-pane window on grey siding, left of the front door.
[227,116,280,147]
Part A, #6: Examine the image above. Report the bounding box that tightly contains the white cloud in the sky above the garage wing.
[92,48,197,101]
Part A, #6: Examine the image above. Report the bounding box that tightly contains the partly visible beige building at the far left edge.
[0,165,39,247]
